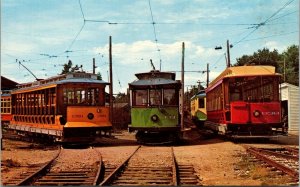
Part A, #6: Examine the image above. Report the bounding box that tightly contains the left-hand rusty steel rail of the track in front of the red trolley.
[247,147,299,178]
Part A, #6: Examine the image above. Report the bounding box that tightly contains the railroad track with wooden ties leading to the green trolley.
[100,146,200,186]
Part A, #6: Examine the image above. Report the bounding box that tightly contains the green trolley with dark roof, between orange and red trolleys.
[129,70,181,144]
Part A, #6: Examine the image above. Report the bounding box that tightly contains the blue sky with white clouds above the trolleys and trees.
[1,0,299,94]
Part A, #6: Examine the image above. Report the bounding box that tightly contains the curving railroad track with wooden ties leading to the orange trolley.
[5,149,103,186]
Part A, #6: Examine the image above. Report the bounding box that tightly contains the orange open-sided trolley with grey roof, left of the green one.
[9,72,112,142]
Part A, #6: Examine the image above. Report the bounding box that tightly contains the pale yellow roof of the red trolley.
[208,66,280,87]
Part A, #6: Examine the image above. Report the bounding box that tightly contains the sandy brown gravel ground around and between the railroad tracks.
[1,132,298,186]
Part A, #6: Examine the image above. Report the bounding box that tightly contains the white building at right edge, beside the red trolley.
[280,83,300,134]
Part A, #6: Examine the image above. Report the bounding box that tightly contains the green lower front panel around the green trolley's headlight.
[131,107,178,127]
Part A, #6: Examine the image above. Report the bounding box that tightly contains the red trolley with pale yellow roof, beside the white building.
[205,66,285,137]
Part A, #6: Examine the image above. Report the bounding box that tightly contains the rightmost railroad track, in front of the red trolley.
[246,146,299,183]
